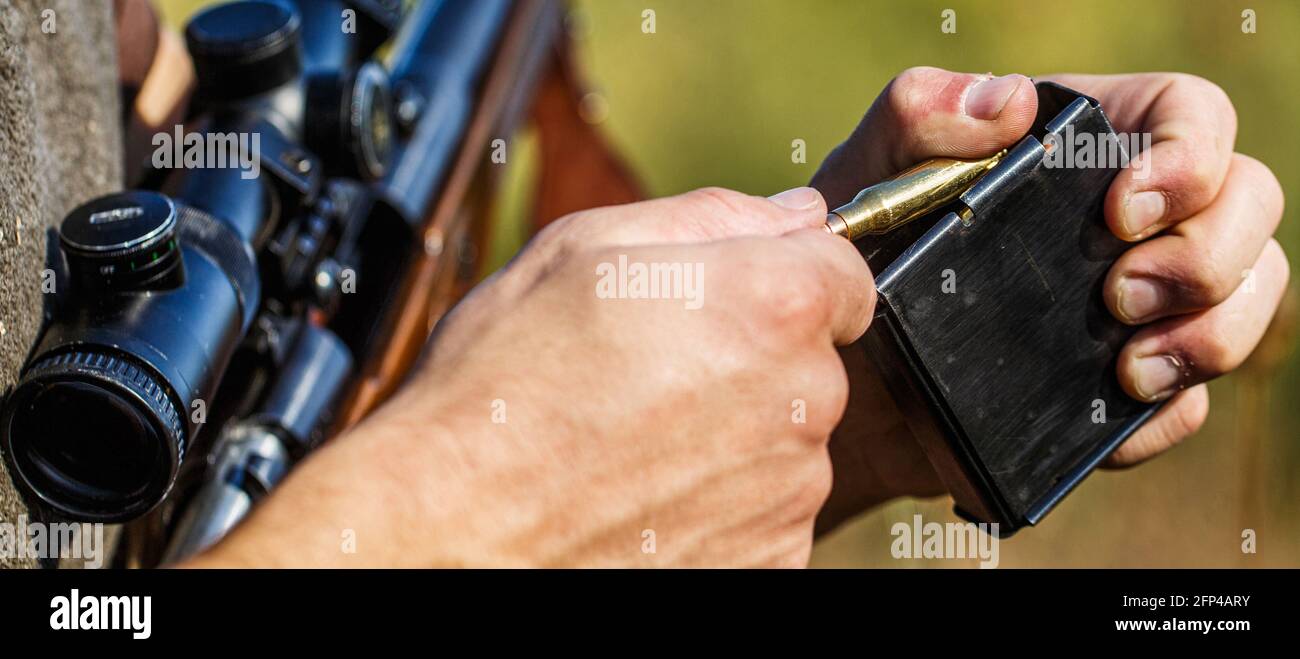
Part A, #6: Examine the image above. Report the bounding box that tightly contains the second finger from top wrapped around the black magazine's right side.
[1104,155,1283,324]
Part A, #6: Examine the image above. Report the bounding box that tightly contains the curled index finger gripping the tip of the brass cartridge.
[781,229,876,346]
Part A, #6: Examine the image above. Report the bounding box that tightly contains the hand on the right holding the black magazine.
[813,68,1288,529]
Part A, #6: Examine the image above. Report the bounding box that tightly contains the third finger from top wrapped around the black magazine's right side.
[1118,240,1290,400]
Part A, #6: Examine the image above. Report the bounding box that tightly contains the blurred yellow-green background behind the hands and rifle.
[160,0,1300,567]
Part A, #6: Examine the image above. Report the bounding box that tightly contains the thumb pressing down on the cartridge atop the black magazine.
[813,66,1039,208]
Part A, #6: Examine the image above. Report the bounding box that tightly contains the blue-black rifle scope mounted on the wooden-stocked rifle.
[0,0,416,523]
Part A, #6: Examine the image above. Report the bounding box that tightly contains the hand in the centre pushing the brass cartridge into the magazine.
[195,188,875,565]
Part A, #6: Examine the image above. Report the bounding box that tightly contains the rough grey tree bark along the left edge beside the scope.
[0,0,122,567]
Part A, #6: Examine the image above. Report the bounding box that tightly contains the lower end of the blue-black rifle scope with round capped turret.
[0,191,260,523]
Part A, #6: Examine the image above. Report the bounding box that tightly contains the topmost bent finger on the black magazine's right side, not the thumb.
[1045,73,1236,240]
